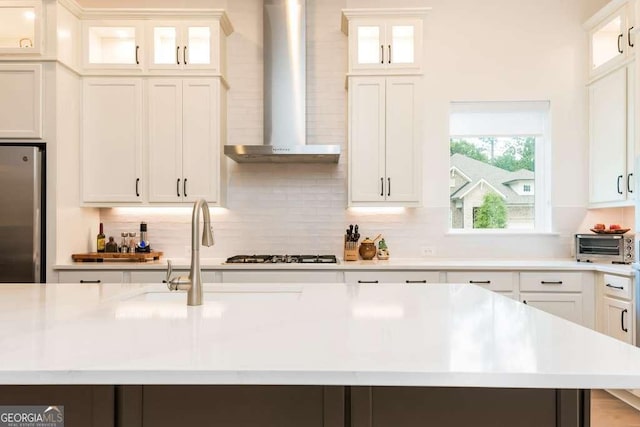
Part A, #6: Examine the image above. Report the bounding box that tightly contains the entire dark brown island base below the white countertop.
[0,385,590,427]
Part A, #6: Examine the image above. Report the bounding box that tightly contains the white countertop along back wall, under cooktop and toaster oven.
[54,258,633,276]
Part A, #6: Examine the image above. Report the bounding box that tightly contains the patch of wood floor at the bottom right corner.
[591,390,640,427]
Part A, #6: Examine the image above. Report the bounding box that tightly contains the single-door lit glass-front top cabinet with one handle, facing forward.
[82,21,144,70]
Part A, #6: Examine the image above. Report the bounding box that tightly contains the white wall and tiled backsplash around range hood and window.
[96,0,616,258]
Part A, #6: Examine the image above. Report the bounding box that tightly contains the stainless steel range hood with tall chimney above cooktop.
[224,0,340,163]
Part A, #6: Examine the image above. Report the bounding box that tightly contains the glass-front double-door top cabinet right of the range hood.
[342,8,428,74]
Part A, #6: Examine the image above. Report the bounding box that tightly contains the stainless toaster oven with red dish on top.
[576,234,634,264]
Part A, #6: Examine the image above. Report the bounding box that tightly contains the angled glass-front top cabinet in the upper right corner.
[585,0,635,77]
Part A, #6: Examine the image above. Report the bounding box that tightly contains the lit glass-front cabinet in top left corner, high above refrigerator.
[0,1,43,54]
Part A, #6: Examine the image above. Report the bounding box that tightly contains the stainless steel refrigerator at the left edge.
[0,142,46,283]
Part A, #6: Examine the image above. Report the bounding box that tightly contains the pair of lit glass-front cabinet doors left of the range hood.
[149,22,219,70]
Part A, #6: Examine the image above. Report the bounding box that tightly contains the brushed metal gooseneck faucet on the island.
[166,199,214,305]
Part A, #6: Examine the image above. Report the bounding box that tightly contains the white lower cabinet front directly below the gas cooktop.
[222,271,341,283]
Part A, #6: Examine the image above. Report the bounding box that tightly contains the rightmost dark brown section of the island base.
[349,387,590,427]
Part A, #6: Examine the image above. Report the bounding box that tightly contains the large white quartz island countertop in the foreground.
[0,283,640,388]
